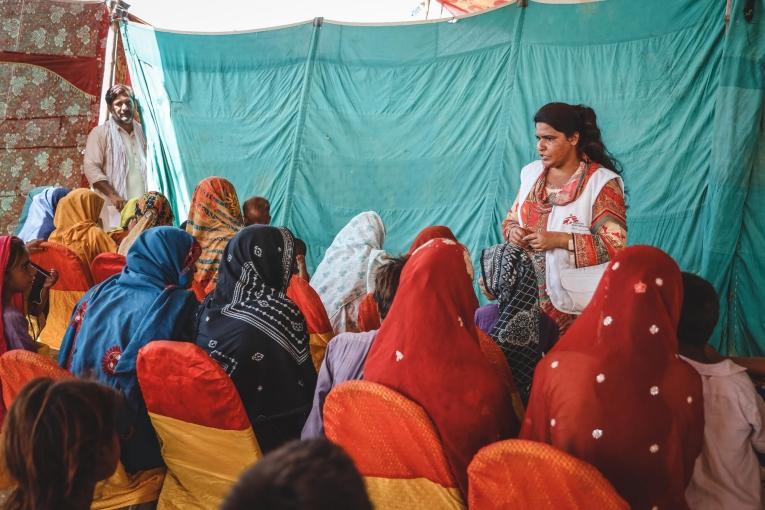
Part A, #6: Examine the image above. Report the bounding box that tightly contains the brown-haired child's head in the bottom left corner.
[2,378,120,510]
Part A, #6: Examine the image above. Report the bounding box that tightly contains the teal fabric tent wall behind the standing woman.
[123,0,765,354]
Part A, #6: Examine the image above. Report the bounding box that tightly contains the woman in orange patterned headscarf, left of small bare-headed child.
[184,177,244,301]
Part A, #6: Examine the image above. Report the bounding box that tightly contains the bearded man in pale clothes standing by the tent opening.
[84,84,146,231]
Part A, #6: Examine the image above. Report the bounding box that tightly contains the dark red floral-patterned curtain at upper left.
[0,0,109,233]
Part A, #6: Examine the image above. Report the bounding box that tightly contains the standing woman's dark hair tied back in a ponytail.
[534,103,621,173]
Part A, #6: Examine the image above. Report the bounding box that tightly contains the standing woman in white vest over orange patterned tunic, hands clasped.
[502,103,627,334]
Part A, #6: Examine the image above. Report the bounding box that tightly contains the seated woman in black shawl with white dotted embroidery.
[196,225,316,453]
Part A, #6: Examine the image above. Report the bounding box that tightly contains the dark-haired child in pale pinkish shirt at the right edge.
[677,273,765,510]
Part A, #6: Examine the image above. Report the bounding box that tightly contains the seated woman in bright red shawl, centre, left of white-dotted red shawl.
[364,239,518,494]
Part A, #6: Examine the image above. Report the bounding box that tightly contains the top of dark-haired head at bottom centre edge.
[221,438,372,510]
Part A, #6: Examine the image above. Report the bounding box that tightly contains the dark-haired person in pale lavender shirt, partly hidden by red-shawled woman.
[301,257,406,439]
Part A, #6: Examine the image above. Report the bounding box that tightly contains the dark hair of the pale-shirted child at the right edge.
[677,273,720,347]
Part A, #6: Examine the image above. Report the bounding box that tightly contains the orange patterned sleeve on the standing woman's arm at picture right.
[574,179,627,267]
